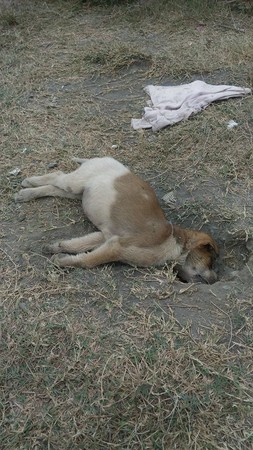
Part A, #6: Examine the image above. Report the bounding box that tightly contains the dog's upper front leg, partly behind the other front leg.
[44,231,105,254]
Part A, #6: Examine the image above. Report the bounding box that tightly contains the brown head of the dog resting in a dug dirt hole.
[175,230,219,284]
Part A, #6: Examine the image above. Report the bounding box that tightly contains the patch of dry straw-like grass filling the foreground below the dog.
[1,304,252,449]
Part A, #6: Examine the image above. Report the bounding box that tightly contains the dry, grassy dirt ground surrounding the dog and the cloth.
[0,0,253,450]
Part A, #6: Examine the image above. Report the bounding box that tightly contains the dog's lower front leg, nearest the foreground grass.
[52,237,121,269]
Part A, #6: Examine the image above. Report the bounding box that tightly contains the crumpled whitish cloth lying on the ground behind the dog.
[131,80,251,131]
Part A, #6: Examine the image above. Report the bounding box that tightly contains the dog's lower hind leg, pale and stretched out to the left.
[14,185,82,202]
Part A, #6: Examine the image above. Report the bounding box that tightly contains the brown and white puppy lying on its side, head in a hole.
[15,157,219,283]
